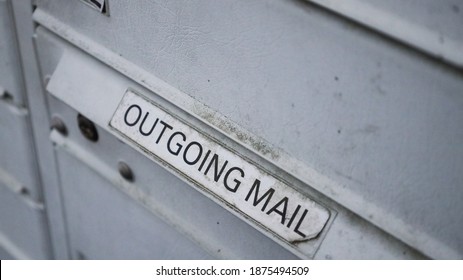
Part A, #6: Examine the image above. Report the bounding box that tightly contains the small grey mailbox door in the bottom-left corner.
[0,182,51,259]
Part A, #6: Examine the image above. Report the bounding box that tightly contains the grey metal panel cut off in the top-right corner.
[307,0,463,69]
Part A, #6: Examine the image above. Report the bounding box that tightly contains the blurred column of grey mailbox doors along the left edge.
[0,1,51,259]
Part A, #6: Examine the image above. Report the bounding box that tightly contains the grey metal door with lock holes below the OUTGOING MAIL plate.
[47,95,295,259]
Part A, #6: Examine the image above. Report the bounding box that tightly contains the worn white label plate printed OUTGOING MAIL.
[110,89,330,243]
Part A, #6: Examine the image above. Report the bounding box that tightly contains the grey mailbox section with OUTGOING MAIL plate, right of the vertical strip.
[0,0,463,259]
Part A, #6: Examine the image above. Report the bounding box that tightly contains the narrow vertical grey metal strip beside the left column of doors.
[8,0,70,259]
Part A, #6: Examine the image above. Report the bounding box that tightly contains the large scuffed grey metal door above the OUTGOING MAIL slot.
[38,0,463,256]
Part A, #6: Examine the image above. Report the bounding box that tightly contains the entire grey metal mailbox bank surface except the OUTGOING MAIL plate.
[0,0,463,259]
